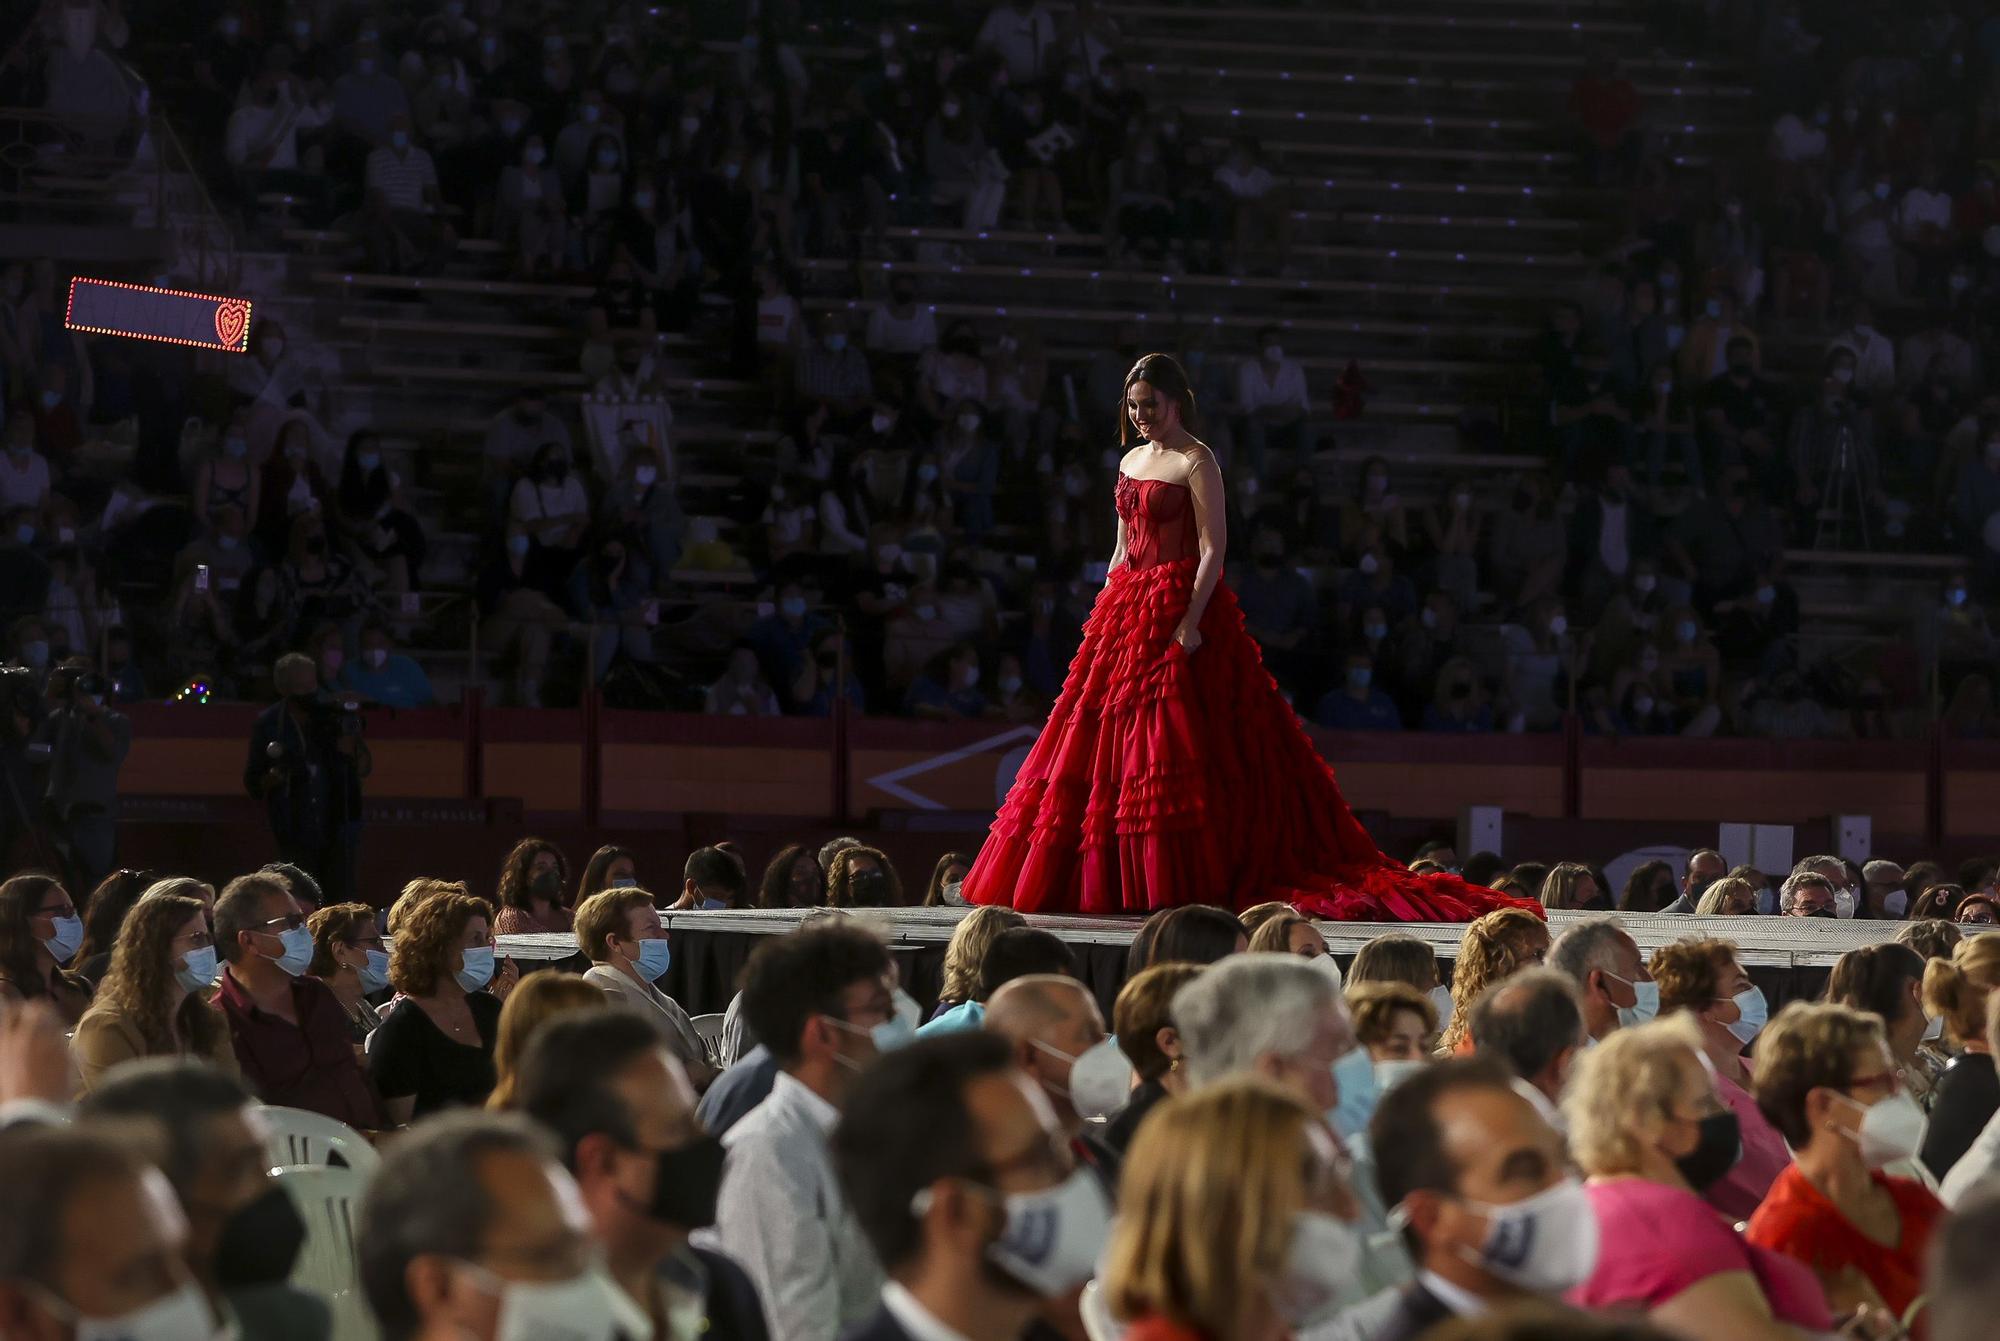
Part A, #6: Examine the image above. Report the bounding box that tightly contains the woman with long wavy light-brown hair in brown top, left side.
[70,881,240,1093]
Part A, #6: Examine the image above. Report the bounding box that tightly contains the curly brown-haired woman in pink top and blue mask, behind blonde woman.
[1648,937,1792,1223]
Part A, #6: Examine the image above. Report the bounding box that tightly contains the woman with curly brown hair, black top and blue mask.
[368,885,504,1125]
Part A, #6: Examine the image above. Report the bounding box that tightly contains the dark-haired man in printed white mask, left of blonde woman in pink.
[1368,1057,1598,1341]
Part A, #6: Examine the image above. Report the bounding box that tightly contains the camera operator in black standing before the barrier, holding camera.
[244,652,374,903]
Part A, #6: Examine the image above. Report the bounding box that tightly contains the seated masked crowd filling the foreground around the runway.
[0,839,2000,1341]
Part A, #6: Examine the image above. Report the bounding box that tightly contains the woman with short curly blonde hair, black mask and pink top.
[1564,1017,1834,1341]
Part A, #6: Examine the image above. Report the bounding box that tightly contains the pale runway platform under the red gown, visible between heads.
[500,909,1902,1015]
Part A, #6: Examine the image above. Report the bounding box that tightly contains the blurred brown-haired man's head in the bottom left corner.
[0,1127,216,1341]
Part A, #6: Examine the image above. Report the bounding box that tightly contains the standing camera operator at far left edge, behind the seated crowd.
[36,656,132,891]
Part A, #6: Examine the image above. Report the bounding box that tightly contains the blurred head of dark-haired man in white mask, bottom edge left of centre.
[354,1113,652,1341]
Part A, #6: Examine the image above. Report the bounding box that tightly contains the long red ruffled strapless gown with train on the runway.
[964,472,1540,923]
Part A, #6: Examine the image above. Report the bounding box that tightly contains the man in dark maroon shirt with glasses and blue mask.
[216,875,386,1131]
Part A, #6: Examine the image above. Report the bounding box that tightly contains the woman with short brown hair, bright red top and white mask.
[1746,1004,1944,1337]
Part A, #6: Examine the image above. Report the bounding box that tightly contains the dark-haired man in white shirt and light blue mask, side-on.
[714,919,912,1341]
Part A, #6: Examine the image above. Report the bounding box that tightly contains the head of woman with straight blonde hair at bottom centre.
[1104,1077,1360,1341]
